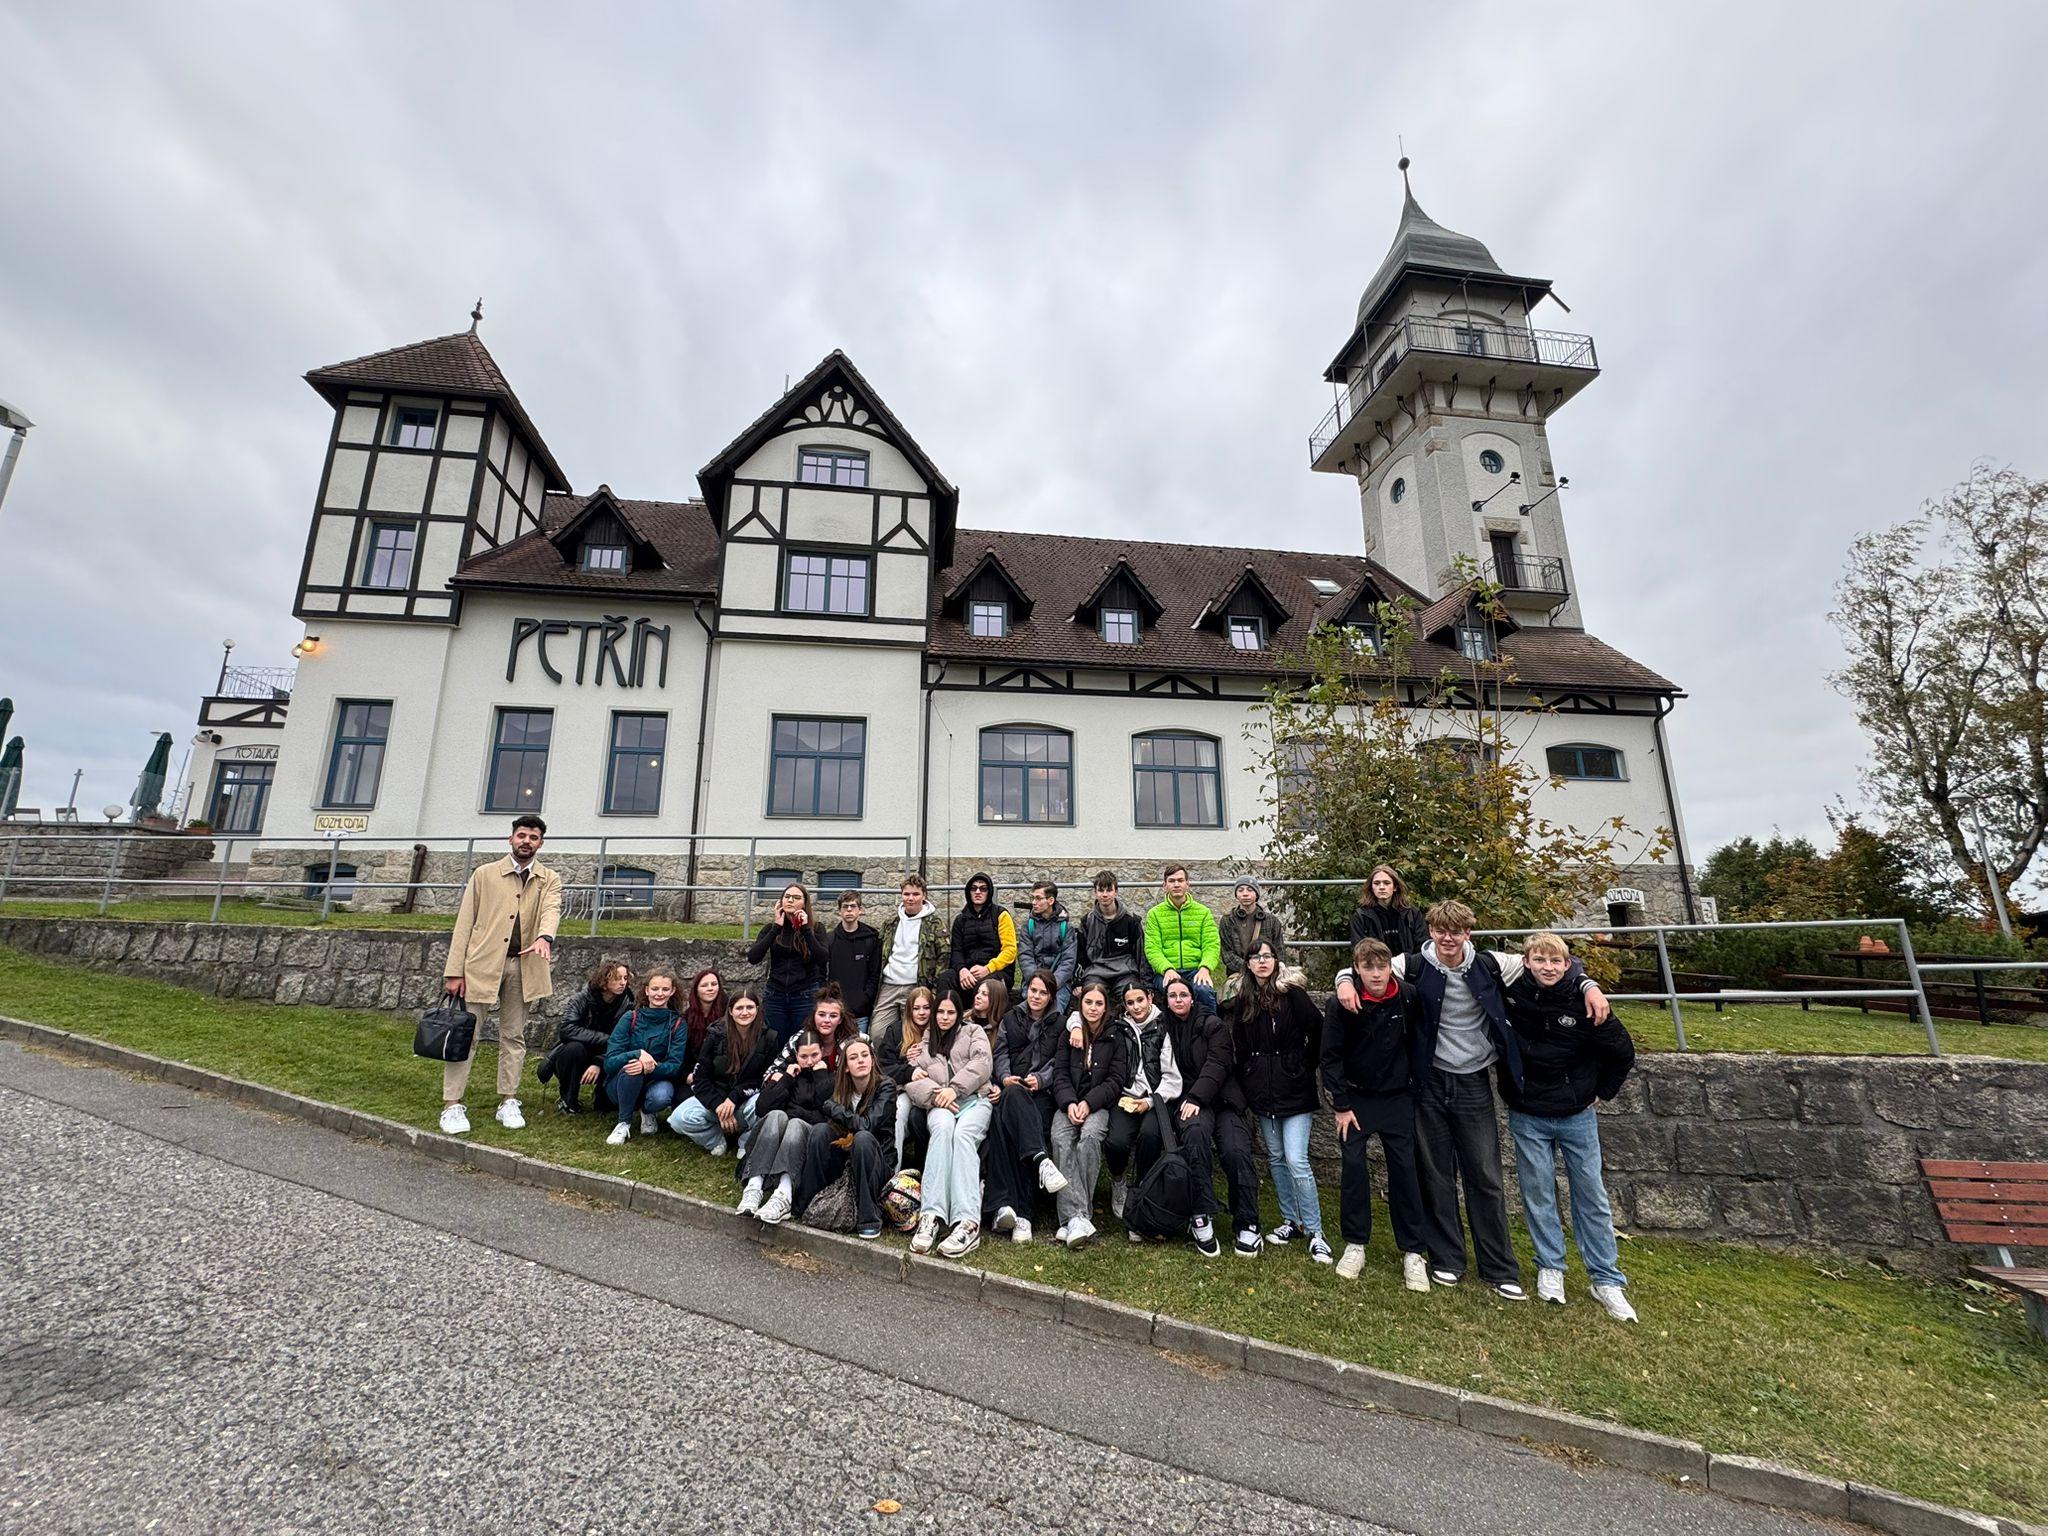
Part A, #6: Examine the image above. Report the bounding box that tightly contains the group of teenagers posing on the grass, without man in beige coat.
[539,864,1636,1323]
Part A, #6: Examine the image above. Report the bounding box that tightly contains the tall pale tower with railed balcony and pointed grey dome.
[1309,158,1599,629]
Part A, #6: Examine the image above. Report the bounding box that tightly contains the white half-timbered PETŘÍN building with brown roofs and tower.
[190,174,1692,915]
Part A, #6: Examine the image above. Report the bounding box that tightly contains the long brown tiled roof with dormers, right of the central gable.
[930,528,1677,692]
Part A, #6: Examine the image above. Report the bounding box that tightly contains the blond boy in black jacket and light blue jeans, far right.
[1499,934,1636,1323]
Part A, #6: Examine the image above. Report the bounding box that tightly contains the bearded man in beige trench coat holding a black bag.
[440,815,561,1137]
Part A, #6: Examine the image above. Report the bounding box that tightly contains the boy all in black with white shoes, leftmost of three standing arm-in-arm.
[1323,938,1430,1290]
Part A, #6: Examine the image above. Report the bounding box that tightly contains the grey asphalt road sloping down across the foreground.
[0,1042,1833,1536]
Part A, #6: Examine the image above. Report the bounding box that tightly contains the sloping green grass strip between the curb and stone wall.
[0,948,2048,1520]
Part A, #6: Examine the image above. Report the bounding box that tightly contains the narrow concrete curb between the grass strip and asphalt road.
[0,1014,2015,1536]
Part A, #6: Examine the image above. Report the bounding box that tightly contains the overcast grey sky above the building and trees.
[0,0,2048,858]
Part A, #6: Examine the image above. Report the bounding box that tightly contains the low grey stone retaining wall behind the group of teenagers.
[0,918,2048,1272]
